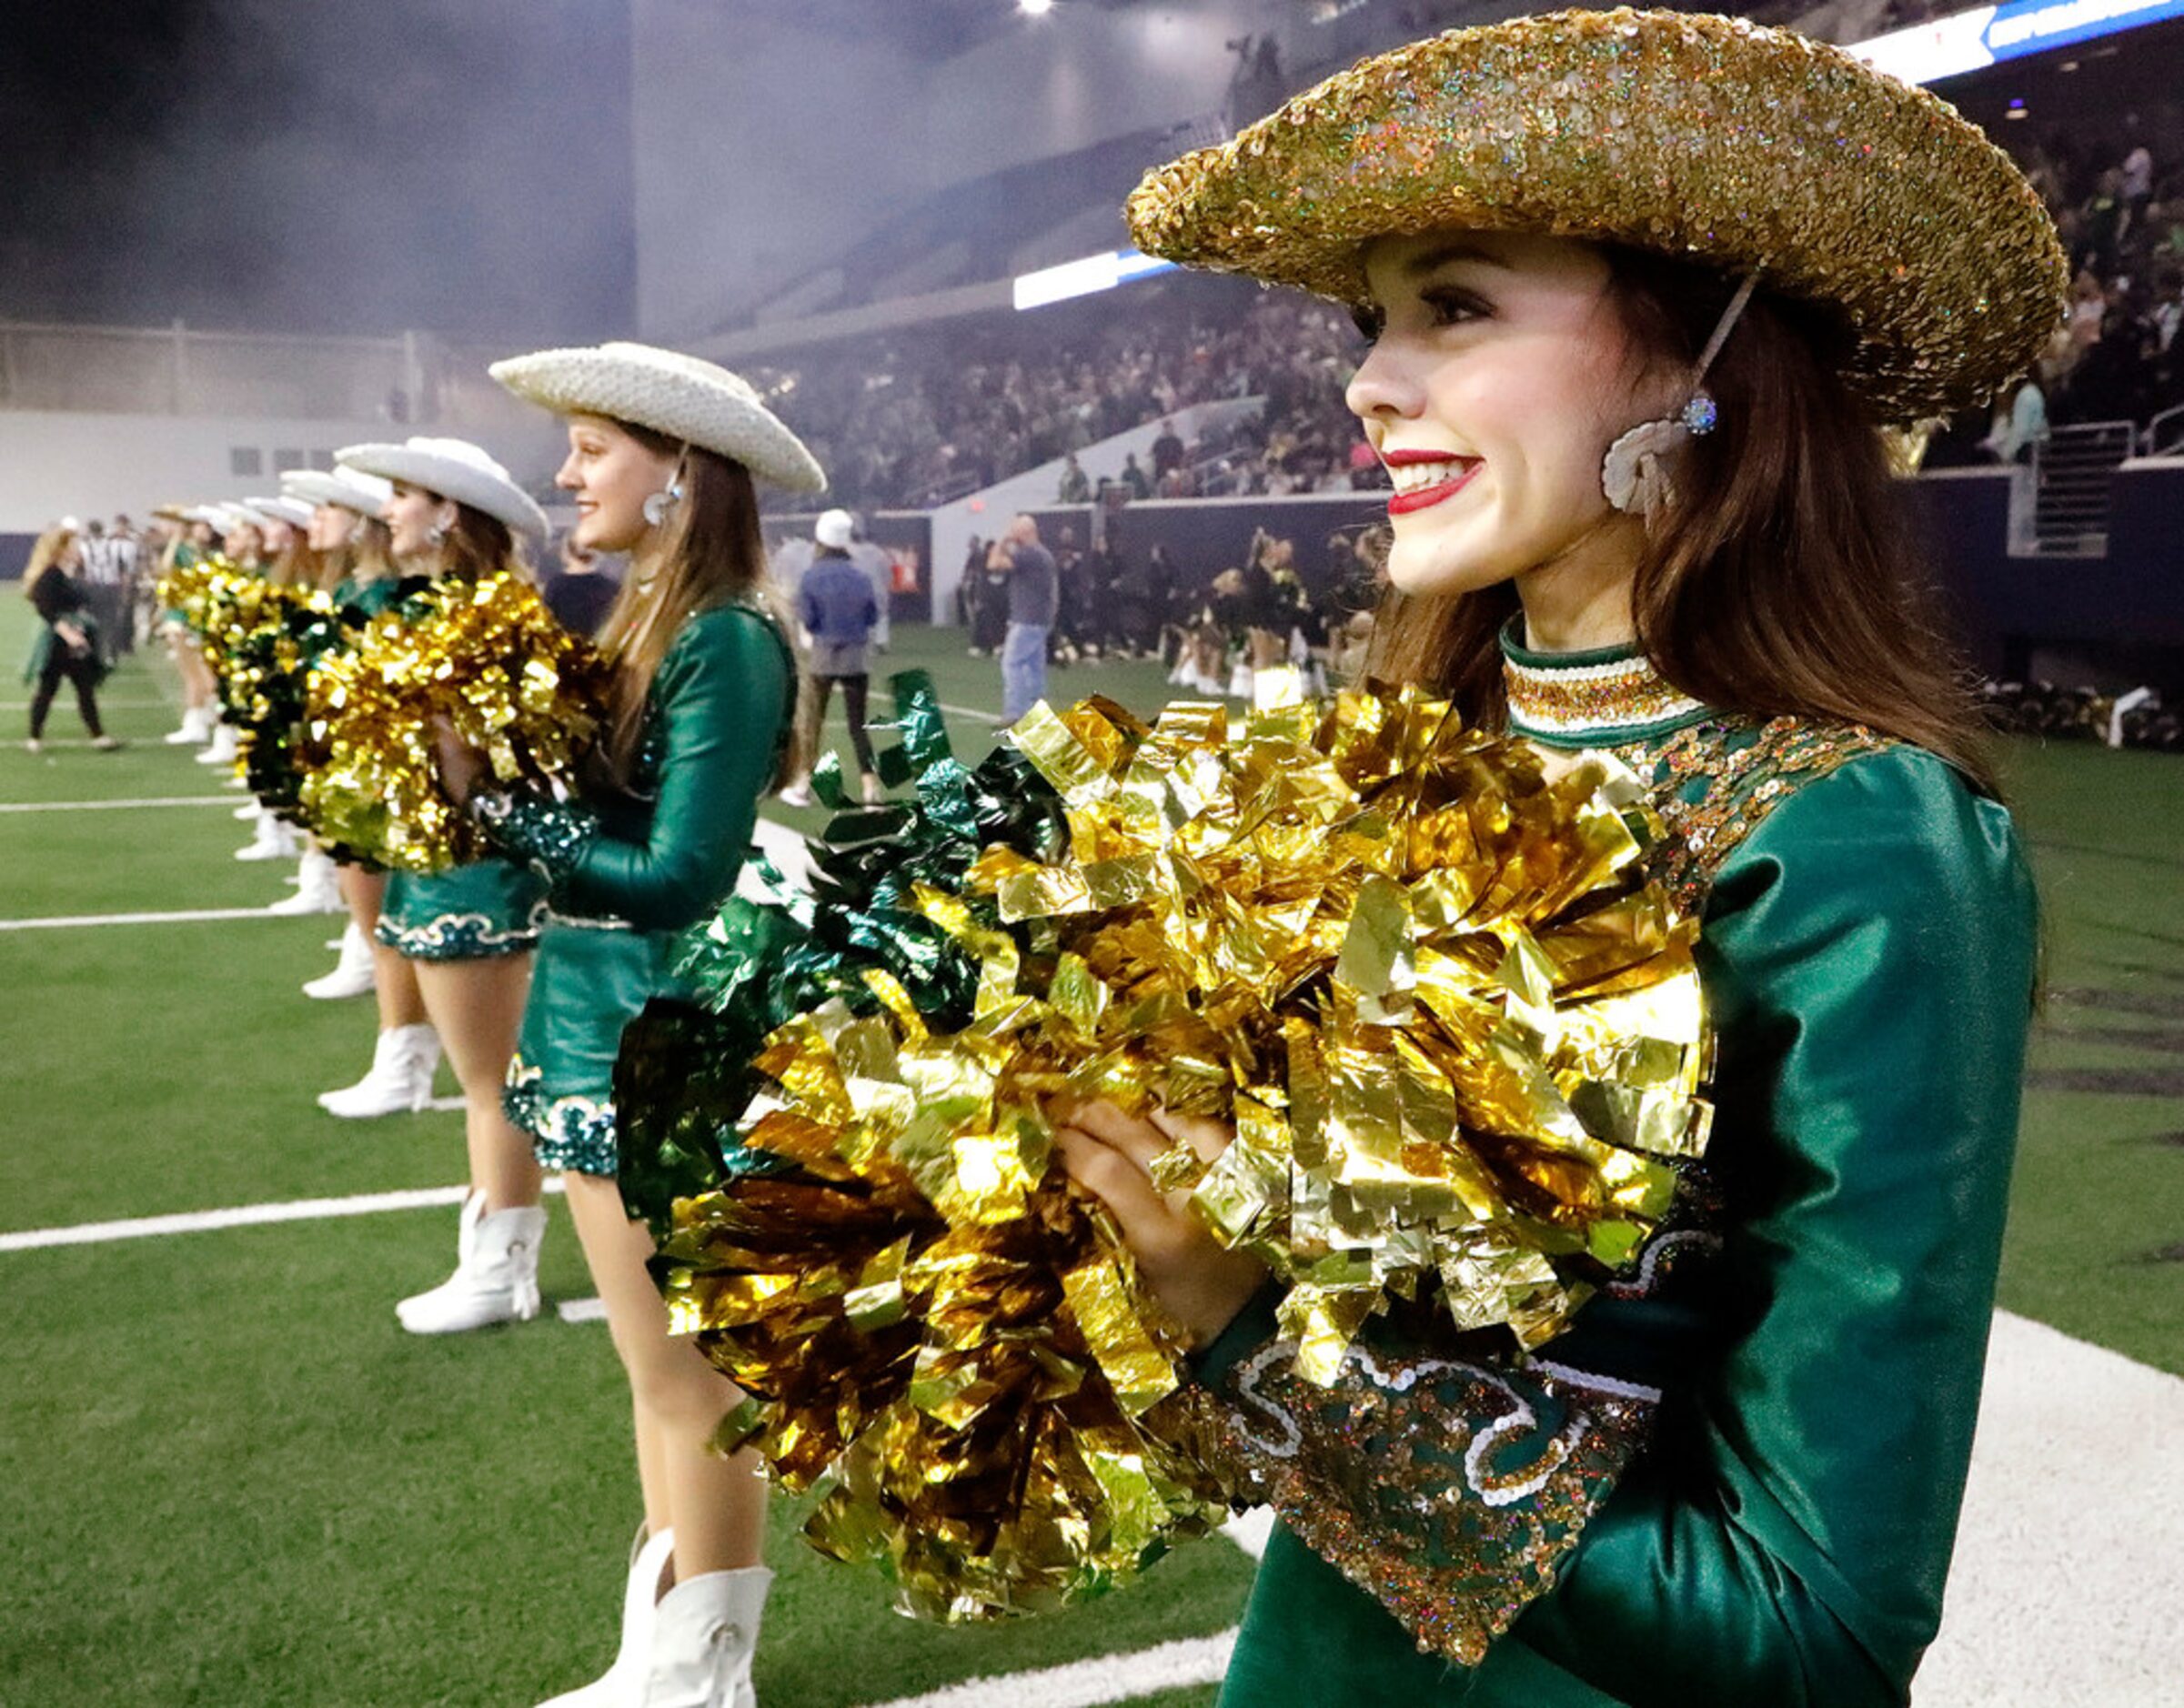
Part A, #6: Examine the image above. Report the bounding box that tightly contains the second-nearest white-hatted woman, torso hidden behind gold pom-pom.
[321,439,546,1334]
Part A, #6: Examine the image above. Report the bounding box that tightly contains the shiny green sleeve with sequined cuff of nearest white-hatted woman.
[494,605,793,930]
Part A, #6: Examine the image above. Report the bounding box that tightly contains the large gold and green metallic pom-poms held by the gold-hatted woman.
[638,684,1710,1619]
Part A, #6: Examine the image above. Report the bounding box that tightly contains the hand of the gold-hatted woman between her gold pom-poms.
[1052,1103,1267,1350]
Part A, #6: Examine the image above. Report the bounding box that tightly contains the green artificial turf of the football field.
[0,597,2184,1708]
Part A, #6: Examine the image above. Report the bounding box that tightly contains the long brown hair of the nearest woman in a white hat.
[599,421,806,789]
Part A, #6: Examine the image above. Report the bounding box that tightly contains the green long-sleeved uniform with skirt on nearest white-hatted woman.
[478,605,797,1175]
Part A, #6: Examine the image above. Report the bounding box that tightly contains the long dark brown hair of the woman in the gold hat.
[1372,245,1998,795]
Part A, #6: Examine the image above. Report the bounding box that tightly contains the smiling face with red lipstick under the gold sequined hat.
[1347,232,1684,609]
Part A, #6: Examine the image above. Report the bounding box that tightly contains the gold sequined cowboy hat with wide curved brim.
[1127,11,2068,426]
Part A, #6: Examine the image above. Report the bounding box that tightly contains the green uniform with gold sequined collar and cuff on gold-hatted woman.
[1199,640,2036,1708]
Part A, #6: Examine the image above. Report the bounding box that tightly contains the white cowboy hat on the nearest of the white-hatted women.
[487,343,826,491]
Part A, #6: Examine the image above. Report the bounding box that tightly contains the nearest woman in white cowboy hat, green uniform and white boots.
[441,343,826,1708]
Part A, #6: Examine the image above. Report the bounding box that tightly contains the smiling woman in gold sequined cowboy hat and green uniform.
[1059,13,2066,1708]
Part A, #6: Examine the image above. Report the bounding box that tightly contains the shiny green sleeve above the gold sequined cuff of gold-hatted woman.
[1511,749,2036,1708]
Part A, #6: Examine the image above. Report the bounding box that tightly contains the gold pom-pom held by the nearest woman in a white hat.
[299,575,605,871]
